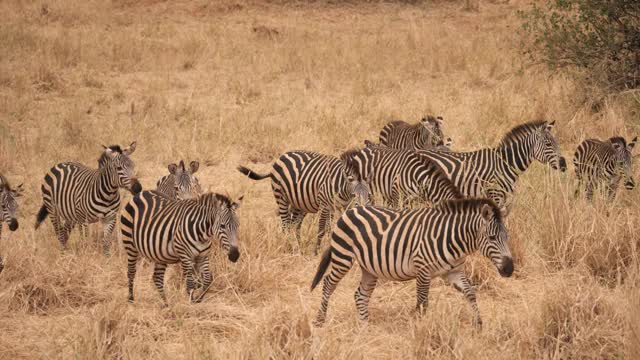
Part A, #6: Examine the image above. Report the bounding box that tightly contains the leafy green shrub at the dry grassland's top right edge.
[520,0,640,90]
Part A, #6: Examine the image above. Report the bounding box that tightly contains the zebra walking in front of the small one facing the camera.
[120,191,242,305]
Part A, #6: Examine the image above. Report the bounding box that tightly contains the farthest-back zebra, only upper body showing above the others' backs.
[380,115,444,150]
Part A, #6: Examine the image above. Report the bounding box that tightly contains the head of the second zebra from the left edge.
[98,141,142,195]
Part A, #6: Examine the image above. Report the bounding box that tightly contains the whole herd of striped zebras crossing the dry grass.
[0,116,637,327]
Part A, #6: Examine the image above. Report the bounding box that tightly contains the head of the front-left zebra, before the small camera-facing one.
[206,193,244,262]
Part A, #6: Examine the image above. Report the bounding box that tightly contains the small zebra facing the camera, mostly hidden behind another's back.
[156,160,202,200]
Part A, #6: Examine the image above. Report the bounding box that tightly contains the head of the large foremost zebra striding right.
[478,203,513,277]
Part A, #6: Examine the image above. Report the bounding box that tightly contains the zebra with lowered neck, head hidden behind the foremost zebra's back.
[343,142,462,208]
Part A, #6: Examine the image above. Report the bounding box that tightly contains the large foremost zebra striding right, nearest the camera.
[311,199,513,328]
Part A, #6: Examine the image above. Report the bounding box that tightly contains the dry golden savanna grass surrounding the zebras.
[0,0,640,359]
